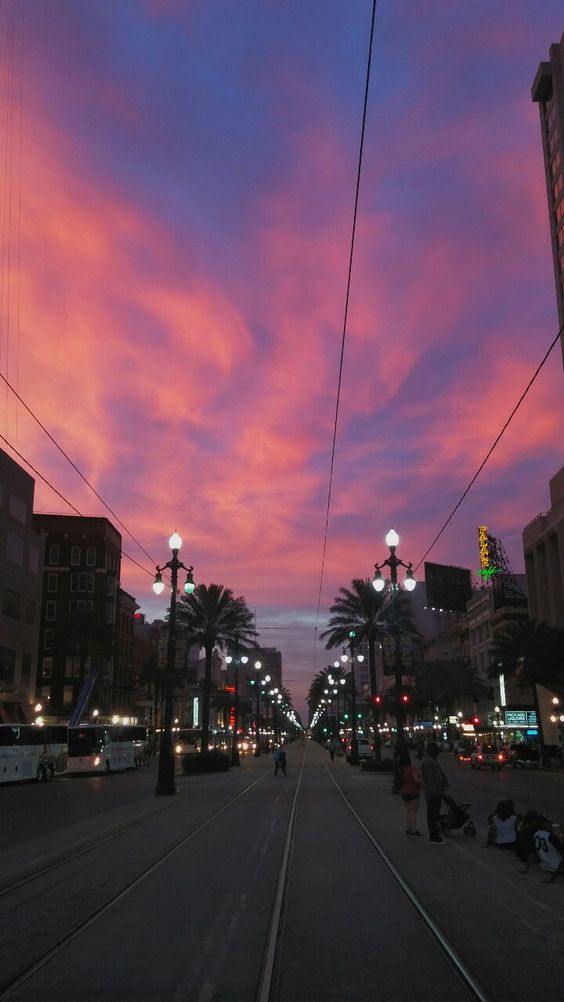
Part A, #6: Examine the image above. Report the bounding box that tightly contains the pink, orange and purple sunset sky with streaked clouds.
[0,0,564,710]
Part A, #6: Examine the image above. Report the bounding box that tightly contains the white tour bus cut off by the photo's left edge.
[0,723,67,783]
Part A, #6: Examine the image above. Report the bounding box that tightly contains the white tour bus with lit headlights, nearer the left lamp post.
[67,723,148,774]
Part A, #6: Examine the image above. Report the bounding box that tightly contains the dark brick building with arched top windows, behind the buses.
[33,514,123,720]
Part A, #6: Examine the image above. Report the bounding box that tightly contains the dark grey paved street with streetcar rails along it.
[0,742,564,1002]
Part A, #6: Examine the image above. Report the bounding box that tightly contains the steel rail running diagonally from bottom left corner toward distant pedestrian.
[0,770,270,1002]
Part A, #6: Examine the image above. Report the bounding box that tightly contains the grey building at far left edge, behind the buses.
[0,449,44,723]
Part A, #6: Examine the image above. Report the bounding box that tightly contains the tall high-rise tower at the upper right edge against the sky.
[532,34,564,368]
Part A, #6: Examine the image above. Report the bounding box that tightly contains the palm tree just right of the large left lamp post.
[176,584,256,752]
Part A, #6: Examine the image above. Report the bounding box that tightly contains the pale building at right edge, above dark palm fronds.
[523,466,564,629]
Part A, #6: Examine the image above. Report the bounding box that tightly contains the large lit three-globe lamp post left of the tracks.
[152,530,195,797]
